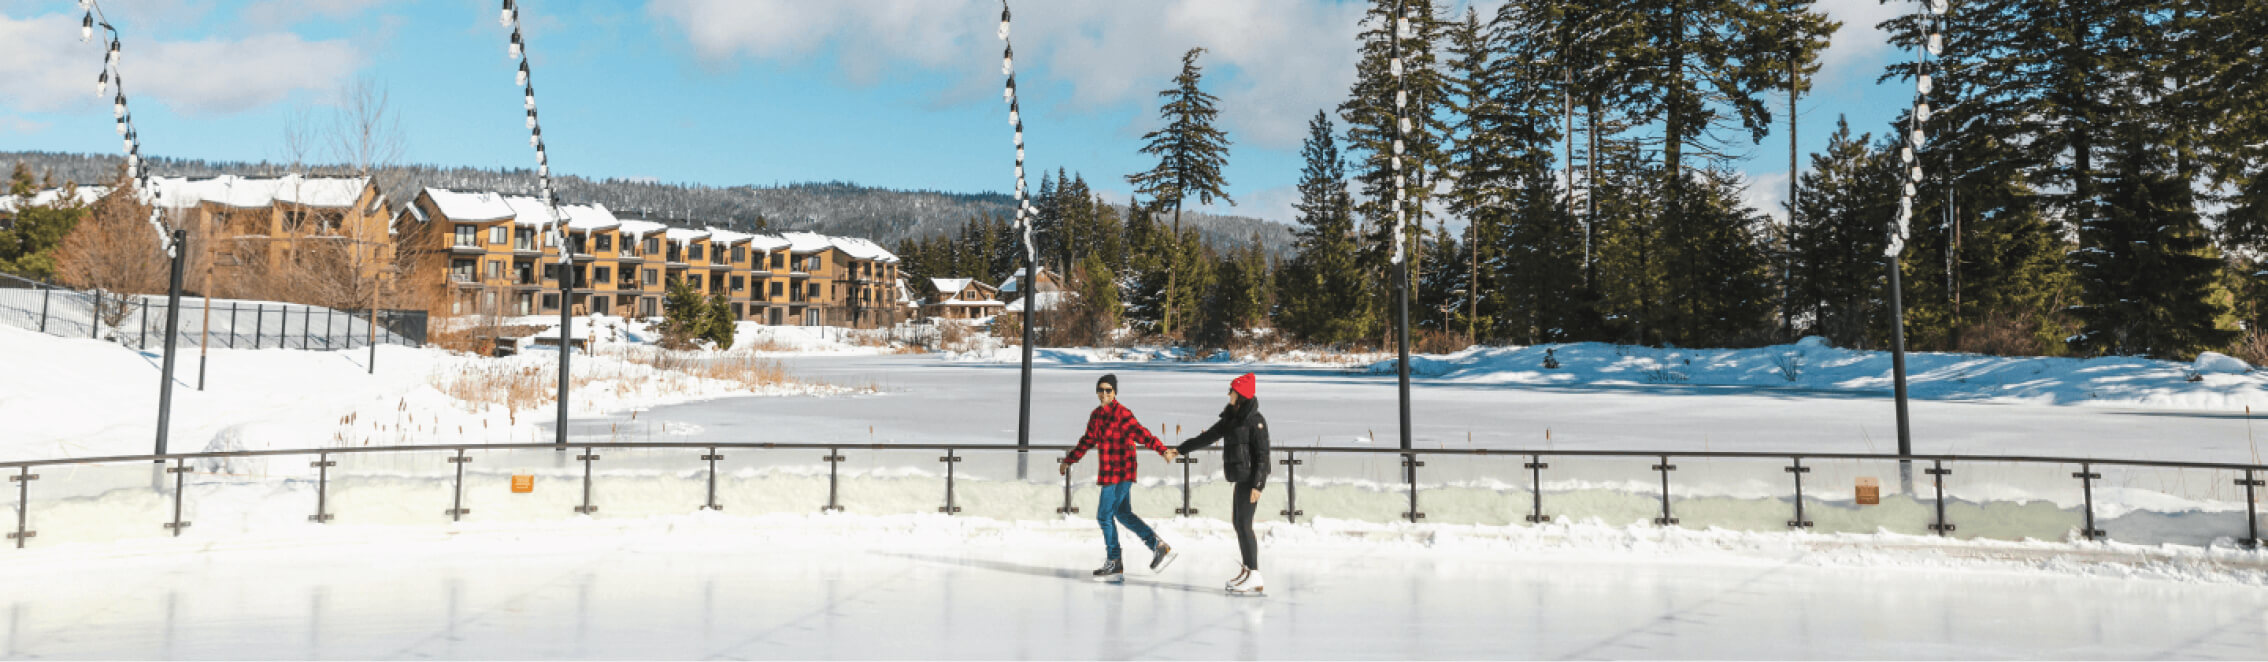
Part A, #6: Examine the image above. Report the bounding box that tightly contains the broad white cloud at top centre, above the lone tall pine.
[649,0,1363,150]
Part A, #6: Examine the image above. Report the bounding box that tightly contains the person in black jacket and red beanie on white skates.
[1175,372,1270,594]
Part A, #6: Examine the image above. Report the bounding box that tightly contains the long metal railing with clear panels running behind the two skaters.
[0,442,2268,549]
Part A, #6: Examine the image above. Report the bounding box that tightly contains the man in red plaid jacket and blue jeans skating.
[1057,374,1177,580]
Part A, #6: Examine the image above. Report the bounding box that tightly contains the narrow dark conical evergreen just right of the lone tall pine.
[1277,111,1379,345]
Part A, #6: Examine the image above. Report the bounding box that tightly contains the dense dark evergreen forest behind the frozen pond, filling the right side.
[875,0,2268,360]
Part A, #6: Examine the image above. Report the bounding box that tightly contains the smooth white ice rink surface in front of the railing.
[0,515,2268,660]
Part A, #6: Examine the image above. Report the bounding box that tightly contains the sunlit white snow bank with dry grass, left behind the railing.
[0,326,835,460]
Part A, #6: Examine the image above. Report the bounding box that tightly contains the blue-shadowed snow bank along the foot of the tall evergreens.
[1370,338,2268,410]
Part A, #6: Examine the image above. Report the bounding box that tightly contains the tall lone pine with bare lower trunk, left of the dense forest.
[1127,48,1236,336]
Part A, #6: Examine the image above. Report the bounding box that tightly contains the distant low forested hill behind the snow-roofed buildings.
[0,152,1290,254]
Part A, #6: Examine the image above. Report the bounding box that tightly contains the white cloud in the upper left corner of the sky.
[0,14,363,113]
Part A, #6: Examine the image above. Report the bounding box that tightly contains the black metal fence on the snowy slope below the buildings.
[0,274,426,349]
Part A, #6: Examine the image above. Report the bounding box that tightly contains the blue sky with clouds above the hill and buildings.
[0,0,1912,220]
